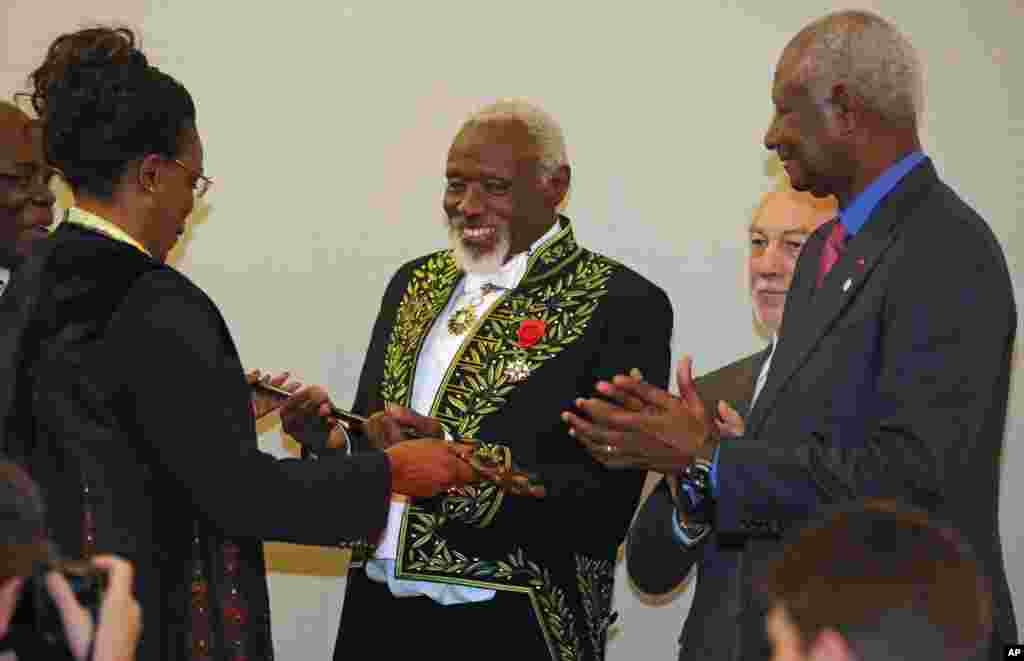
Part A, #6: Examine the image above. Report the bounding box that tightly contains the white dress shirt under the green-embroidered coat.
[366,223,559,606]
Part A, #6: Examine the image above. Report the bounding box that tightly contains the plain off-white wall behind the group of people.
[0,0,1024,660]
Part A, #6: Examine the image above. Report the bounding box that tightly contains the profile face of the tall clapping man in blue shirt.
[765,44,854,196]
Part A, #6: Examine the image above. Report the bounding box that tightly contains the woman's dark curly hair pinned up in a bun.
[29,28,196,199]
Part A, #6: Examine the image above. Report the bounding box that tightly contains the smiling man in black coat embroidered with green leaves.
[335,100,672,660]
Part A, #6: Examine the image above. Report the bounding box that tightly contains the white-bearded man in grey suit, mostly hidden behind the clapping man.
[618,189,836,605]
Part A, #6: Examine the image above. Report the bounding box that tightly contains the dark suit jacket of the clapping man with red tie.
[622,161,1017,660]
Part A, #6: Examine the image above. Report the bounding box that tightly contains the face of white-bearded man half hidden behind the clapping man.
[750,189,838,333]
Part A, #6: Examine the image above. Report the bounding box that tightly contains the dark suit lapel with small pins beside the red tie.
[746,160,937,437]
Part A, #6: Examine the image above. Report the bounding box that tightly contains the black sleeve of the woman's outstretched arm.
[105,270,390,545]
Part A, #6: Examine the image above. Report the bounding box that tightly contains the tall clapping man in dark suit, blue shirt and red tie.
[567,11,1017,661]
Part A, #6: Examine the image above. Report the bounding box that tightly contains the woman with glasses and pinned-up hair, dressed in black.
[5,29,469,661]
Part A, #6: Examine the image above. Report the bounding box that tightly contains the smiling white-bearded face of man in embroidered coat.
[443,117,568,272]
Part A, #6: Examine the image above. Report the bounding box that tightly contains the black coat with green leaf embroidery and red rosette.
[338,218,672,659]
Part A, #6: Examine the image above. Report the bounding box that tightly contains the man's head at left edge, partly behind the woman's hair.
[0,101,54,263]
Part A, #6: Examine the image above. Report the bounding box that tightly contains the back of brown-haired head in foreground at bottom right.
[765,500,992,661]
